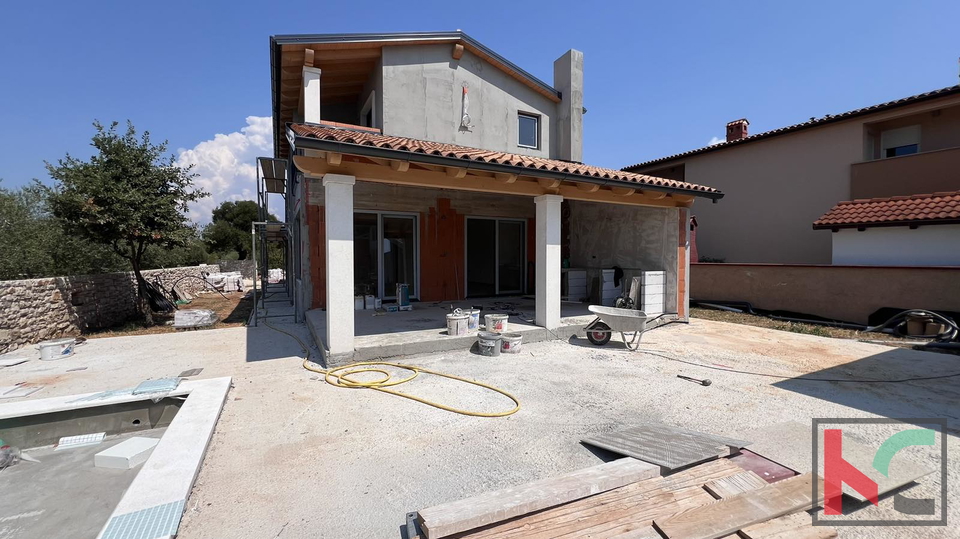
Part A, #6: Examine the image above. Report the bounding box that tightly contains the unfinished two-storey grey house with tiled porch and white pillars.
[270,31,723,354]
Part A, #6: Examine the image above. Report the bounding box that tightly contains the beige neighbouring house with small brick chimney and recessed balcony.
[624,86,960,264]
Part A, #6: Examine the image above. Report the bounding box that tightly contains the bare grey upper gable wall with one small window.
[378,45,559,158]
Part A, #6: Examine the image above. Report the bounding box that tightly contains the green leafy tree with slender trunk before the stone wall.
[47,122,207,322]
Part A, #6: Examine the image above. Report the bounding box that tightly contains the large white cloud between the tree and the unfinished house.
[177,116,282,224]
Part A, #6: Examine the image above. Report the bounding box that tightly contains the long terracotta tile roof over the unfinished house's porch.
[288,124,723,198]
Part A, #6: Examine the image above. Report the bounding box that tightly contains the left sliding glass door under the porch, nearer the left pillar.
[353,212,419,299]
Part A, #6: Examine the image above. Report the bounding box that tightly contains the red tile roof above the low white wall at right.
[813,191,960,229]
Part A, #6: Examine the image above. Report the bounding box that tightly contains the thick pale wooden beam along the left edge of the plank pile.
[418,459,660,539]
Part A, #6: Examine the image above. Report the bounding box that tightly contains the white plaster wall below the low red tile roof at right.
[818,225,960,266]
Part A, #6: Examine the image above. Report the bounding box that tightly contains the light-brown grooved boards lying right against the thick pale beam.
[458,459,743,539]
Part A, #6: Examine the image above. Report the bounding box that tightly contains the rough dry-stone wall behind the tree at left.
[0,265,220,353]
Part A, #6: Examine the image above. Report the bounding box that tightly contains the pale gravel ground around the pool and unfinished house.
[0,320,960,539]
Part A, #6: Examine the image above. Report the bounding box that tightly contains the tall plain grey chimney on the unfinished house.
[553,49,583,163]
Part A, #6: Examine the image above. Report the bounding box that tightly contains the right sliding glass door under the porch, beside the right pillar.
[466,217,526,297]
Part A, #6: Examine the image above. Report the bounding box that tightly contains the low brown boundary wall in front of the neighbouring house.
[690,264,960,324]
